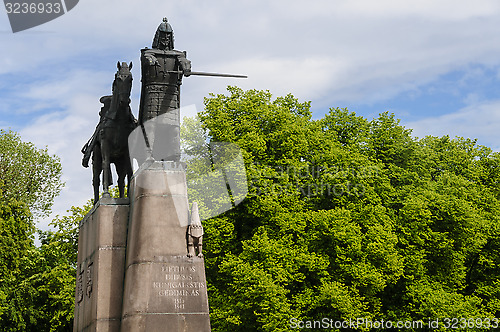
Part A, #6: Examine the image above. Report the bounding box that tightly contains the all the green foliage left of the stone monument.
[0,130,83,331]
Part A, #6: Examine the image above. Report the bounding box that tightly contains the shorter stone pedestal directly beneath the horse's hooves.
[73,198,129,332]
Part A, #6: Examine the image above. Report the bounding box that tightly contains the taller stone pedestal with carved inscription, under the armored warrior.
[121,162,210,332]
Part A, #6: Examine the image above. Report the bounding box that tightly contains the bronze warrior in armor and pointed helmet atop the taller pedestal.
[139,18,191,161]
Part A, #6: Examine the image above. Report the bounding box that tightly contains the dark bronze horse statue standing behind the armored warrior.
[82,62,137,204]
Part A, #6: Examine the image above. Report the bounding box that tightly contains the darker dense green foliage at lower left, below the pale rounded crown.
[0,196,91,331]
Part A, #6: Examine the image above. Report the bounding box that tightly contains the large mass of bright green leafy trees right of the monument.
[189,87,500,331]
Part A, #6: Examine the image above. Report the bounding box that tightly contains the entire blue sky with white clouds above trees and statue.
[0,0,500,228]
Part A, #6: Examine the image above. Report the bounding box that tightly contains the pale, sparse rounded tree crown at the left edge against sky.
[0,129,63,217]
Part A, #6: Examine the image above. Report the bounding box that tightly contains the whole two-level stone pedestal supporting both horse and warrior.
[73,162,210,332]
